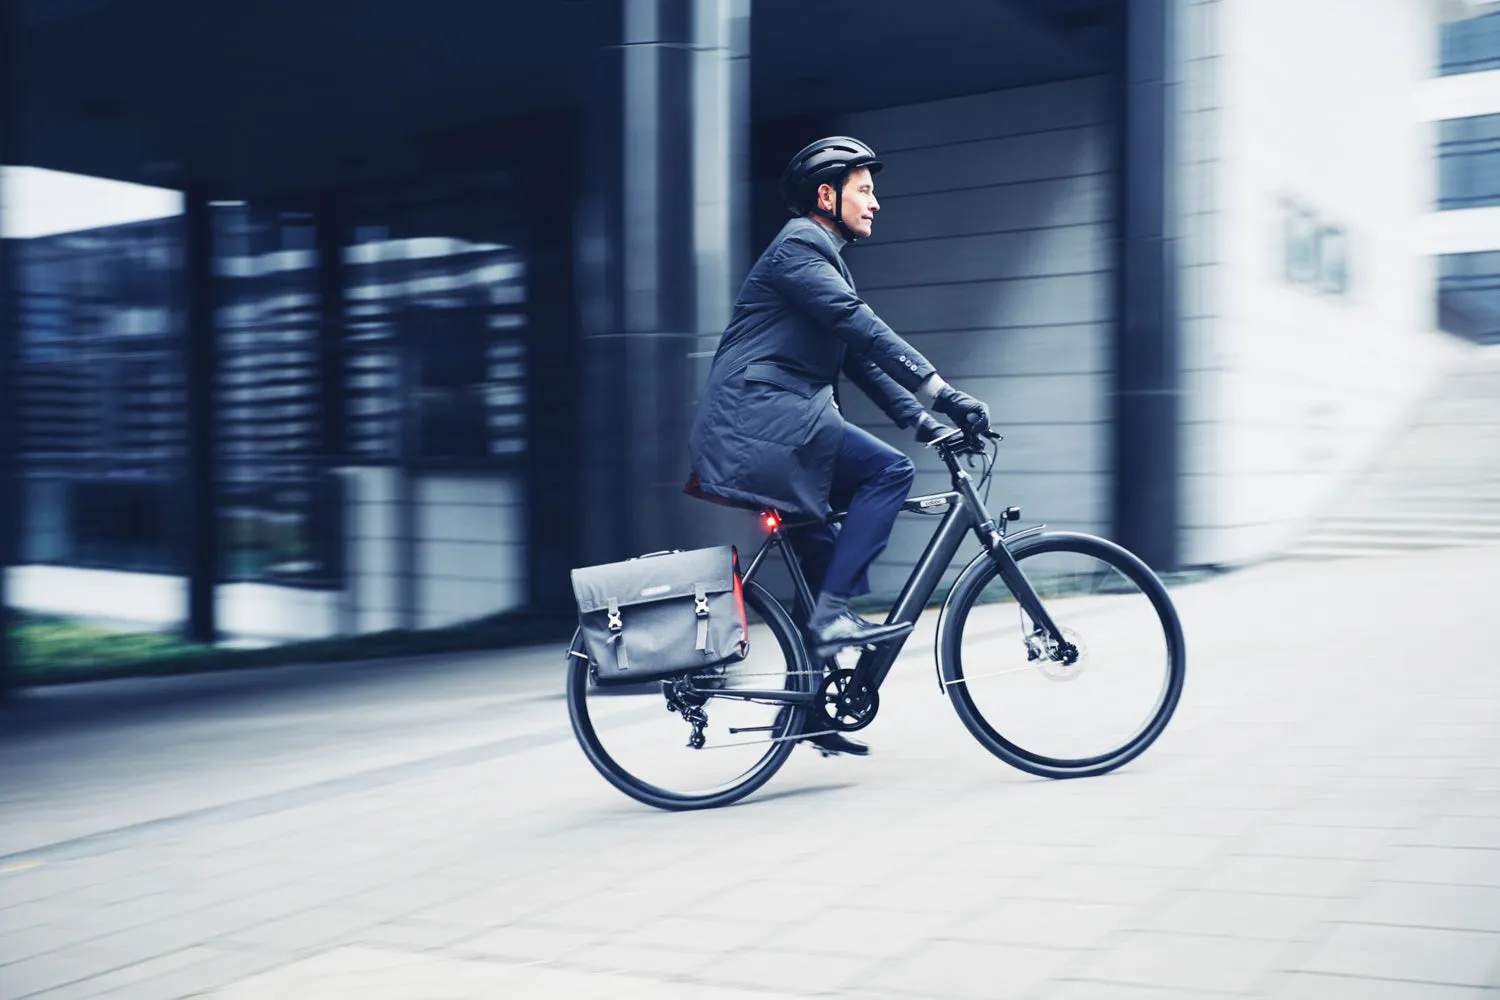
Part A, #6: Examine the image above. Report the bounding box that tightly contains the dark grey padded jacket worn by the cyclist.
[689,219,935,517]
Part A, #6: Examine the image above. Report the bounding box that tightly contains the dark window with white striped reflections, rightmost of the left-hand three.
[344,175,527,466]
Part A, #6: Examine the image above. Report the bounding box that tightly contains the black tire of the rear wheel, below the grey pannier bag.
[567,582,816,811]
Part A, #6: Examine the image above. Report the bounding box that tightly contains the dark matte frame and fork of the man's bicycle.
[729,432,1064,703]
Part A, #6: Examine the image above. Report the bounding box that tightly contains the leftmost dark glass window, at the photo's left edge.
[12,217,185,573]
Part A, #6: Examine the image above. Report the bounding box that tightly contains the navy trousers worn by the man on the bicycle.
[788,423,917,597]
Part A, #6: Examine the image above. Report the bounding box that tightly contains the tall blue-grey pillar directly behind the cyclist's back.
[579,0,749,562]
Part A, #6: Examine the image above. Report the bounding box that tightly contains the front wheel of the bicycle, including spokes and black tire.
[939,532,1187,778]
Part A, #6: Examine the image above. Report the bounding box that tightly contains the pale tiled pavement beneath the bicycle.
[0,549,1500,1000]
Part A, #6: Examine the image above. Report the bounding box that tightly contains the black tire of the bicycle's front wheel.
[938,532,1187,778]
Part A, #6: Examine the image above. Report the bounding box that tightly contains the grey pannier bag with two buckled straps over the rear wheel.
[573,546,750,684]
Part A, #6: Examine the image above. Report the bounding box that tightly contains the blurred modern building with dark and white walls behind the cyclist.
[0,0,1500,677]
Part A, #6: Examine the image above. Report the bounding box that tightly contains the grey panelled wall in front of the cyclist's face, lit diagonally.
[839,78,1113,602]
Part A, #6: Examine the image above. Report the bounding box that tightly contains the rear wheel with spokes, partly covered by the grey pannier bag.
[567,582,819,810]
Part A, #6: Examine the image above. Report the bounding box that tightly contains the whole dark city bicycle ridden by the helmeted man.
[567,430,1187,810]
